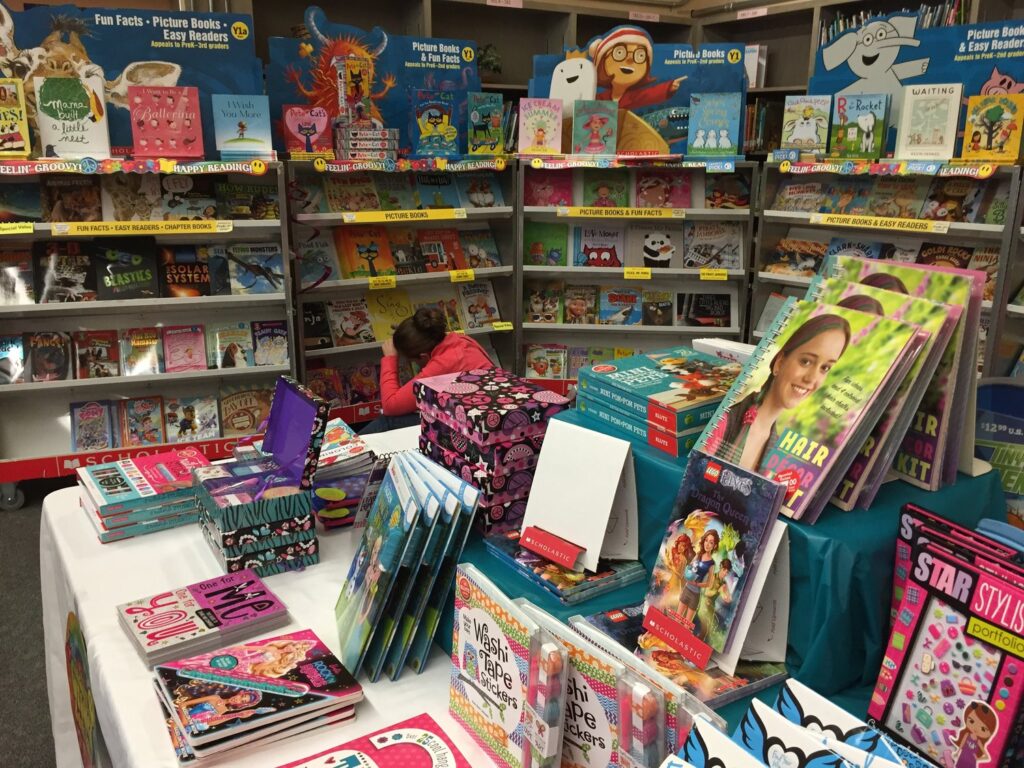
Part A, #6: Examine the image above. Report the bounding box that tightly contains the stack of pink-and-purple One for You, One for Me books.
[117,570,288,667]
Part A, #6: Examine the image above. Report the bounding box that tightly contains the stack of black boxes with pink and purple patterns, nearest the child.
[414,368,568,534]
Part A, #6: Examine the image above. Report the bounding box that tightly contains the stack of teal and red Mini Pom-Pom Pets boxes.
[577,347,740,457]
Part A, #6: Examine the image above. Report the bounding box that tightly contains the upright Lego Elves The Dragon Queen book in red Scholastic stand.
[644,451,784,669]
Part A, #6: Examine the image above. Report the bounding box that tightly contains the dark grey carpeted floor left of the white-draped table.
[0,479,71,768]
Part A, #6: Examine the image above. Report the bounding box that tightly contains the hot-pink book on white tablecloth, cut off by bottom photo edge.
[281,716,472,768]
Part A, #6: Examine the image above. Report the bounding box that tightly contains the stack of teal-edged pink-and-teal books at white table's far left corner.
[77,446,210,544]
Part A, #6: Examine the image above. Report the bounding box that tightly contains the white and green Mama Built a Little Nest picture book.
[33,75,111,160]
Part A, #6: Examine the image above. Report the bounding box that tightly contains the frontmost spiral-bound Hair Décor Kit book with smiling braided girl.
[696,300,921,522]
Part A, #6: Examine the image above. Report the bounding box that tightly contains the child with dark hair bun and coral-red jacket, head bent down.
[360,307,495,434]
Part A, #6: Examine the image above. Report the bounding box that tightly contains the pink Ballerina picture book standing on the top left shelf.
[128,85,204,160]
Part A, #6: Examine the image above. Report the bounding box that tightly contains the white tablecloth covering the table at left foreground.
[38,427,488,768]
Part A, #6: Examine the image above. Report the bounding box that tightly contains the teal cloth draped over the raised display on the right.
[437,411,1006,723]
